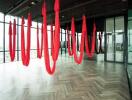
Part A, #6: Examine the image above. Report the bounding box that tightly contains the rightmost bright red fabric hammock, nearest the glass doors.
[85,22,96,58]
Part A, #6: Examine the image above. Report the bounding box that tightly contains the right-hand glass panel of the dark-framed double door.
[115,16,124,62]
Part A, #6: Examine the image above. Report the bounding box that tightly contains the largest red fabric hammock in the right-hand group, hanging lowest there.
[71,16,86,64]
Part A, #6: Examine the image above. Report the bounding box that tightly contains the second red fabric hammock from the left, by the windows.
[21,13,32,66]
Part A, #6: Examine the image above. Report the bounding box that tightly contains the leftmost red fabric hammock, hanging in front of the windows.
[9,19,16,61]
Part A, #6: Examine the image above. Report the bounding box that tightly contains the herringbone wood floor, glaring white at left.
[0,57,130,100]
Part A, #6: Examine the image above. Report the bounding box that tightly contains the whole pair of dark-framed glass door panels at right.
[106,16,125,62]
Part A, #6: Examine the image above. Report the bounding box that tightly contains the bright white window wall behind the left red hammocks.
[0,13,54,63]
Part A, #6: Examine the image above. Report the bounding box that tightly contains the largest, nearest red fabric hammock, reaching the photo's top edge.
[42,0,60,75]
